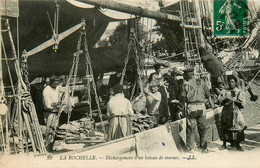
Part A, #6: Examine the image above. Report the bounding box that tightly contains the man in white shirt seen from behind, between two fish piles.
[107,84,134,140]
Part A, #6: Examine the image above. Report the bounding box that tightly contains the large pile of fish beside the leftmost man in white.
[56,118,105,144]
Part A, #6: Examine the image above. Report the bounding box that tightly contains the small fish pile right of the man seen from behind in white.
[131,113,155,134]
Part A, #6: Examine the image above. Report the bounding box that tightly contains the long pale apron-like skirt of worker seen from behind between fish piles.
[108,117,132,140]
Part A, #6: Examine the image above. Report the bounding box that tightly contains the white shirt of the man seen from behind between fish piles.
[107,93,134,116]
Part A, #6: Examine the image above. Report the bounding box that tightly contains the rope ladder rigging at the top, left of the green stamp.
[180,0,209,67]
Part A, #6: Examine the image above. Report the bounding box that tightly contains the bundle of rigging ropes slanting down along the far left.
[1,19,46,153]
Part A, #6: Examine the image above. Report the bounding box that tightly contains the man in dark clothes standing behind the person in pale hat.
[148,64,169,124]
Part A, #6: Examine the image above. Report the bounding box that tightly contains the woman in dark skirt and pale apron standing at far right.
[218,75,247,151]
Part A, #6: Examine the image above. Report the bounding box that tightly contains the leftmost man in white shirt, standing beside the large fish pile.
[42,75,61,150]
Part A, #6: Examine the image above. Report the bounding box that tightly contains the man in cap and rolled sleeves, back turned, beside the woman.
[181,68,210,153]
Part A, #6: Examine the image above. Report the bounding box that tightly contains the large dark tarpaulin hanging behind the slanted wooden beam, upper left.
[3,0,139,80]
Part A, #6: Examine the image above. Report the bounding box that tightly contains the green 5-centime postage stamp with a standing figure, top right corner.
[213,0,249,37]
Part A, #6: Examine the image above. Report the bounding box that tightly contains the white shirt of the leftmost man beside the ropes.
[42,85,60,110]
